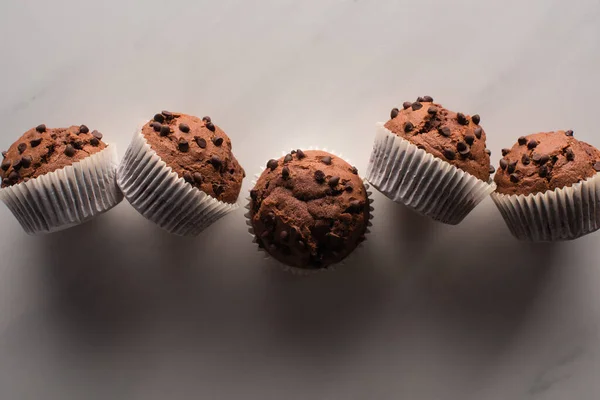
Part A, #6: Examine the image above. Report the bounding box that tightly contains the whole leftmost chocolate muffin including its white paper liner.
[0,125,123,235]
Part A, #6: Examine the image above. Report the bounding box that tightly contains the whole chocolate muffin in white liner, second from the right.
[367,96,495,225]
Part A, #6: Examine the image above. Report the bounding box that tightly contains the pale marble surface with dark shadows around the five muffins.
[0,0,600,400]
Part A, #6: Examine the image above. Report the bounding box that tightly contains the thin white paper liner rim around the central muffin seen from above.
[244,147,374,276]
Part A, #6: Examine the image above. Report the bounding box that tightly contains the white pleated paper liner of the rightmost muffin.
[492,174,600,242]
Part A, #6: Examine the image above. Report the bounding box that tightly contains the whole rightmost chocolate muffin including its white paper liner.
[492,130,600,242]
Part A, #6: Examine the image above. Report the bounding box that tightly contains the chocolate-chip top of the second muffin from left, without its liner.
[142,111,246,203]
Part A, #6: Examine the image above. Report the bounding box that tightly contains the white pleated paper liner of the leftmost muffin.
[0,145,123,235]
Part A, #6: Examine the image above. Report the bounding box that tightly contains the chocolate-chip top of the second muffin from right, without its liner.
[385,96,494,182]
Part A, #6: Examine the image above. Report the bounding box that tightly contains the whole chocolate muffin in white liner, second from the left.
[117,111,245,236]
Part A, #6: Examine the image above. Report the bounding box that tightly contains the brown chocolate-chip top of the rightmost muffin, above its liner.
[494,130,600,195]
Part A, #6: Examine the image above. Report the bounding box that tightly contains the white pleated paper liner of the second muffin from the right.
[366,124,496,225]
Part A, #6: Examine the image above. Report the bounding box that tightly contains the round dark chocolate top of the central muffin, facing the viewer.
[250,150,370,269]
